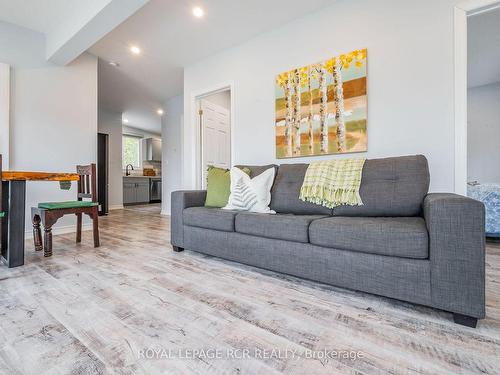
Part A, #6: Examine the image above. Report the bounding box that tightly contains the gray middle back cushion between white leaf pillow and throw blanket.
[271,164,332,215]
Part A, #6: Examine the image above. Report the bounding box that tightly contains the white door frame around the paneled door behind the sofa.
[190,81,235,189]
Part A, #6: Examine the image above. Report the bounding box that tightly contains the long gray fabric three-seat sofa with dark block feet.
[171,155,485,327]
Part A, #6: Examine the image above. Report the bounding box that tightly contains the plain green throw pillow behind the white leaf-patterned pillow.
[205,166,250,208]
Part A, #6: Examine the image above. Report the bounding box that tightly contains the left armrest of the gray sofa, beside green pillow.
[170,190,207,247]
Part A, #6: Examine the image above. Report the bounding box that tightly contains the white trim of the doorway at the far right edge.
[453,0,500,195]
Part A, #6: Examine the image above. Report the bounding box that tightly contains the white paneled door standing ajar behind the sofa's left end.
[200,99,231,189]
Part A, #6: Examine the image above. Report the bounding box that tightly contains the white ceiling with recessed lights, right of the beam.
[90,0,335,101]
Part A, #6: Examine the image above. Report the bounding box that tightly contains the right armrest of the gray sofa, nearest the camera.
[424,193,485,318]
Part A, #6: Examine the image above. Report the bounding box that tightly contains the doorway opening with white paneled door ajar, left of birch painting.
[196,88,232,189]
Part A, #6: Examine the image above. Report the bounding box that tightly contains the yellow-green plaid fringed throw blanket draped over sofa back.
[299,159,366,208]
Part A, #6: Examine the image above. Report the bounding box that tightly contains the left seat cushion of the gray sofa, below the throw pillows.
[182,207,238,232]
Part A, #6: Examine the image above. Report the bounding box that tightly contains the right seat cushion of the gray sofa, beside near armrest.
[309,217,429,259]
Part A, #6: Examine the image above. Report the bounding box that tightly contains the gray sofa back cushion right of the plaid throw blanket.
[333,155,429,217]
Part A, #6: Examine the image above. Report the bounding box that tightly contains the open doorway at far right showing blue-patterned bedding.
[467,7,500,238]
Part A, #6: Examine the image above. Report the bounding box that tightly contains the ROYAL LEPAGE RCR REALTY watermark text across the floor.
[138,347,364,361]
